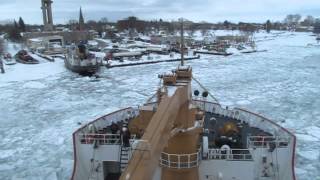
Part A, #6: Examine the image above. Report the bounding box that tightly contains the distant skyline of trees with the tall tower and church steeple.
[0,0,320,41]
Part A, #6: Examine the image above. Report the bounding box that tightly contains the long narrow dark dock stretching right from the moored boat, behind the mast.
[106,55,200,69]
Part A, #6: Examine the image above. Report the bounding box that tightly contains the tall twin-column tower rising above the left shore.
[41,0,53,31]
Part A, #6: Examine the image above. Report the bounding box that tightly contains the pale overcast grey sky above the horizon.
[0,0,320,24]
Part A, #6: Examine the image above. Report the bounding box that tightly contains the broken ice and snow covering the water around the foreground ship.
[0,33,320,180]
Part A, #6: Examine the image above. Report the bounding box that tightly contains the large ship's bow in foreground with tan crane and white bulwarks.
[71,19,296,180]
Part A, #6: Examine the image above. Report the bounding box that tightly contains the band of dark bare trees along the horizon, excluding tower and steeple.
[0,14,320,41]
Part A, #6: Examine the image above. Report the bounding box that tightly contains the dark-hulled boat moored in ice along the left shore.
[64,44,101,75]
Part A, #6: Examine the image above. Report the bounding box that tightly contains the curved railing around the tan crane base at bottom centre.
[160,152,200,169]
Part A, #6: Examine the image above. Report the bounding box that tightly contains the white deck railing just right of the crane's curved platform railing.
[203,149,253,161]
